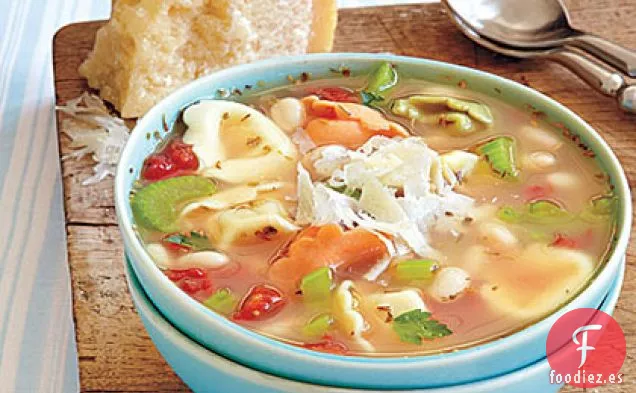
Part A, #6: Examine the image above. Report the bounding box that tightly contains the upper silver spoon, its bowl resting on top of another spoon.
[442,0,636,77]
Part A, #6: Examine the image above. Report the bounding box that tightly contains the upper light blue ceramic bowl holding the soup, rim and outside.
[115,53,632,389]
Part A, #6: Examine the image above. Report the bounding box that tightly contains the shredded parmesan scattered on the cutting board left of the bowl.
[56,92,130,185]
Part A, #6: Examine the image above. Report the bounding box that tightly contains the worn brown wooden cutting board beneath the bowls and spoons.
[53,0,636,393]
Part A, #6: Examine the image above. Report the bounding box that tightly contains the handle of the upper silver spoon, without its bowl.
[567,33,636,77]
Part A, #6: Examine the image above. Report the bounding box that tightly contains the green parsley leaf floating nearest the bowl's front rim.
[393,309,453,344]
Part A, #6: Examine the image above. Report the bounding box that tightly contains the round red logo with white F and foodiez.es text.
[546,308,626,388]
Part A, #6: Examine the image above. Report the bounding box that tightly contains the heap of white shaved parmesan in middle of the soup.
[297,136,474,258]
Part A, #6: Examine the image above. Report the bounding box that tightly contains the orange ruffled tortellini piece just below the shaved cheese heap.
[269,224,387,288]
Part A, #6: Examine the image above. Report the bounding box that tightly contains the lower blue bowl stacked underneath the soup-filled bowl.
[126,256,624,393]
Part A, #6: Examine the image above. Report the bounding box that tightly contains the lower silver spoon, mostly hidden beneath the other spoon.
[443,0,636,113]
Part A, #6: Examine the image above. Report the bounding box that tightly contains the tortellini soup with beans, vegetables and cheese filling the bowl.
[131,64,616,356]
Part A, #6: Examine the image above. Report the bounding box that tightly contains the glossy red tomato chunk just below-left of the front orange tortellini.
[234,285,286,321]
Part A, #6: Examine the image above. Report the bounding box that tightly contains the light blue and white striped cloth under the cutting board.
[0,0,430,393]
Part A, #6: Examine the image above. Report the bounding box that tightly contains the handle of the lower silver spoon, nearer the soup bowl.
[544,49,636,113]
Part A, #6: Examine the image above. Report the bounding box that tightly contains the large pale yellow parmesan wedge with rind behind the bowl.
[79,0,337,118]
